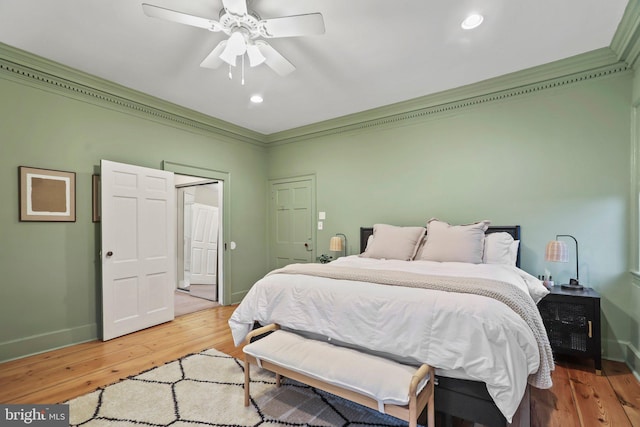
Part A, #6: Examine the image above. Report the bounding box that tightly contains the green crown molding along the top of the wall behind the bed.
[266,47,630,145]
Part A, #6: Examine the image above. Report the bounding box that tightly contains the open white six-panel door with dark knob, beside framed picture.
[101,160,176,341]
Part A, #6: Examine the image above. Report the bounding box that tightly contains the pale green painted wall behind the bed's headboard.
[268,72,632,358]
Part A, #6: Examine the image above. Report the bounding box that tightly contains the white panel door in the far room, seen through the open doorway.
[191,203,219,285]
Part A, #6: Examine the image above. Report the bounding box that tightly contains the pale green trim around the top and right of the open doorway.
[162,160,232,305]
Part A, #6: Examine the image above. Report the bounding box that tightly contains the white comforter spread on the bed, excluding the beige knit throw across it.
[229,256,546,421]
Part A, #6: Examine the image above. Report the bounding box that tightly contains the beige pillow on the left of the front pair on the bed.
[360,224,426,261]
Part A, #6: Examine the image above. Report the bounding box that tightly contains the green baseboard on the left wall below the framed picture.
[0,323,98,362]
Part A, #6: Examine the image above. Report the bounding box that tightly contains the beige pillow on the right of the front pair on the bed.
[420,219,490,264]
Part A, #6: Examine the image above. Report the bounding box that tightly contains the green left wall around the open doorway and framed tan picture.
[0,76,266,360]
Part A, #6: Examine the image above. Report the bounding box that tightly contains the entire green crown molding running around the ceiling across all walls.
[0,41,640,147]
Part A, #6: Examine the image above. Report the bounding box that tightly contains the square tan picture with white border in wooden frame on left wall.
[18,166,76,222]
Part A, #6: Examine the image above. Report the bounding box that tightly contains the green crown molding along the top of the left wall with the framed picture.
[0,43,264,147]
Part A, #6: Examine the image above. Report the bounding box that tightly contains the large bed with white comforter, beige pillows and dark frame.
[229,221,554,426]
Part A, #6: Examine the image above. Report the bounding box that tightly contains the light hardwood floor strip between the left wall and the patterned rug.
[0,306,242,403]
